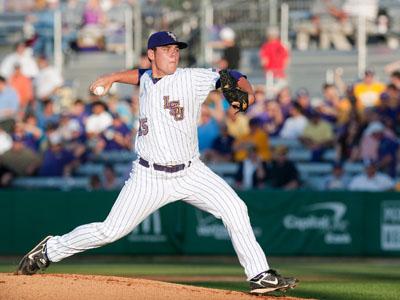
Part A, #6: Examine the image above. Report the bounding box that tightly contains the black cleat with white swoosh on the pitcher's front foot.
[250,269,299,294]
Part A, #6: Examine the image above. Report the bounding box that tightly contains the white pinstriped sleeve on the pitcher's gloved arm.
[191,68,219,103]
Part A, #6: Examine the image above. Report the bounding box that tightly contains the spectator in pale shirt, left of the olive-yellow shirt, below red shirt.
[279,102,307,139]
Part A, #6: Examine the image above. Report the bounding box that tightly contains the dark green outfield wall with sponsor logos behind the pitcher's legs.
[0,190,400,256]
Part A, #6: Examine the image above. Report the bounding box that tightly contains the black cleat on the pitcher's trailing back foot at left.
[15,235,52,275]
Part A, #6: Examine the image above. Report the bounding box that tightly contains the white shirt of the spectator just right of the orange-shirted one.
[35,66,64,99]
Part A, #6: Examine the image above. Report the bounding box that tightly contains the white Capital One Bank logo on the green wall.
[283,202,352,245]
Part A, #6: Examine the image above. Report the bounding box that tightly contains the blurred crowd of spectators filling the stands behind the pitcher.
[0,0,400,190]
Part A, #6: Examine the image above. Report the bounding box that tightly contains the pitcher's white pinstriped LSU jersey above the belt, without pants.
[136,68,219,165]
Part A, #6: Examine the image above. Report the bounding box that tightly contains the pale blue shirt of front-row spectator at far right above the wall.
[349,172,395,192]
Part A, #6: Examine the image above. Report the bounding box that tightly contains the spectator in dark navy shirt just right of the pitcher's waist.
[204,124,235,162]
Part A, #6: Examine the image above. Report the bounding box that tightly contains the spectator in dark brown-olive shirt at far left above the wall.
[0,135,41,176]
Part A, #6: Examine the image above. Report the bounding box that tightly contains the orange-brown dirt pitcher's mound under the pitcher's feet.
[0,273,302,300]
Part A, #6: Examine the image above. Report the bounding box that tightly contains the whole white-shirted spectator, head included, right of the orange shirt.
[34,56,64,101]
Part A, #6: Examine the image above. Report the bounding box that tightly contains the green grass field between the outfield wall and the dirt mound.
[0,258,400,300]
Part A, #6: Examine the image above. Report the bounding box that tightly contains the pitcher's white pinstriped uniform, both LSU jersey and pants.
[46,69,269,280]
